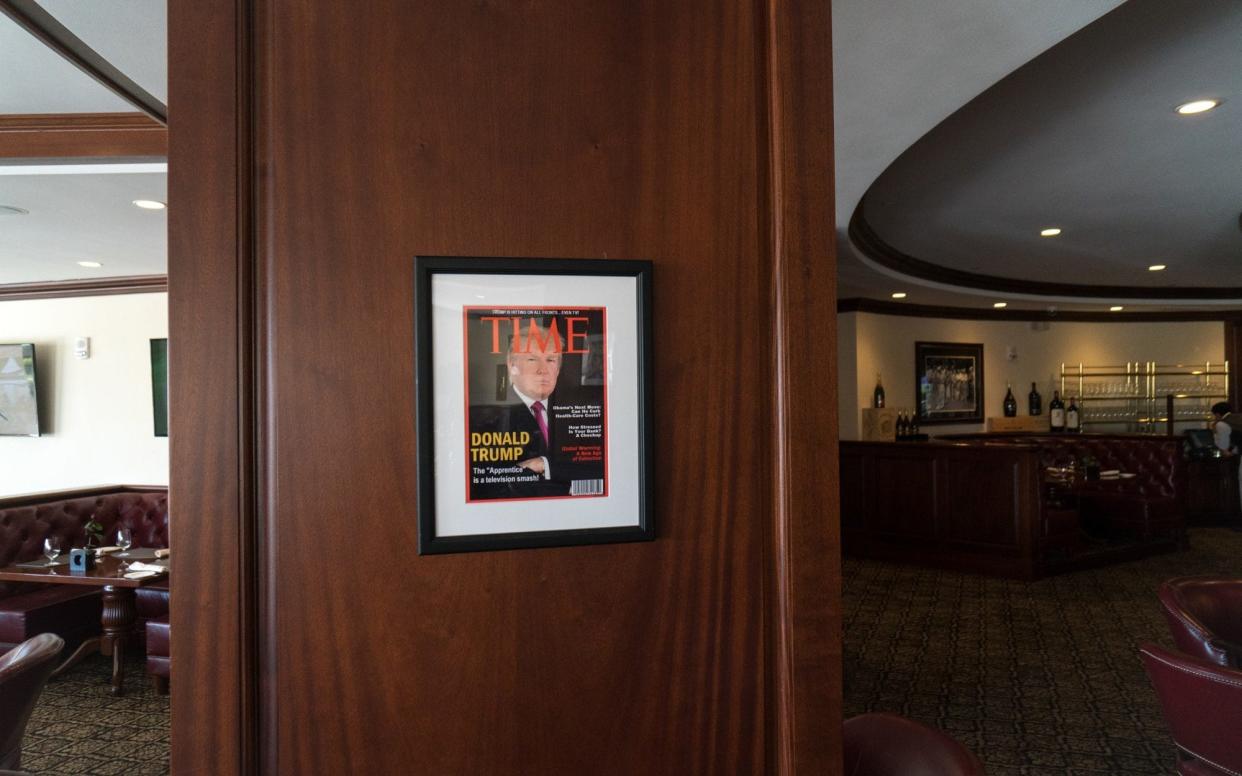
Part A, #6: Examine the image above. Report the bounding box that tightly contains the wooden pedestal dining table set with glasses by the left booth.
[0,549,169,695]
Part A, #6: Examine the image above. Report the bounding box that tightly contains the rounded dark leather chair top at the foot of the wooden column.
[843,714,984,776]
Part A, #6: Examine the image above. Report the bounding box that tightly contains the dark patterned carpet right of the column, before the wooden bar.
[843,528,1242,776]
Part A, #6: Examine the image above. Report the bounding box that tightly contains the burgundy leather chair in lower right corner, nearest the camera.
[1139,644,1242,776]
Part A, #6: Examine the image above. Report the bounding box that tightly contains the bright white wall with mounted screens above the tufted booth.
[0,293,168,497]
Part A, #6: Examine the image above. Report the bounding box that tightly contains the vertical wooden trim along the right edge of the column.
[766,0,842,775]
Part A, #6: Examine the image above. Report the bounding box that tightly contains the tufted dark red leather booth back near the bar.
[945,433,1186,500]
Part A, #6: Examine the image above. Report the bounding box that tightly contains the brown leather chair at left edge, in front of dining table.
[0,633,65,770]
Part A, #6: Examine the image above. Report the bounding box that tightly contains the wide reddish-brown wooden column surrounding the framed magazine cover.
[170,0,841,775]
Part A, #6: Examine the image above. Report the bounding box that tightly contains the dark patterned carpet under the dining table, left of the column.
[21,654,169,776]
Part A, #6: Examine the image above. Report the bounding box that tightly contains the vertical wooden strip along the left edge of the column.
[168,0,252,776]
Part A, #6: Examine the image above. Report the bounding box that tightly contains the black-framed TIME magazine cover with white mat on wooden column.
[414,256,655,555]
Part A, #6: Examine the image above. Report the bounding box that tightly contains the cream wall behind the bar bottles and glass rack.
[837,313,1233,440]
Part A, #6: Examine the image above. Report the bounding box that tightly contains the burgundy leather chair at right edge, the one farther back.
[1156,576,1242,668]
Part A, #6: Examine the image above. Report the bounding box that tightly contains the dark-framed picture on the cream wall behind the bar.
[914,343,984,426]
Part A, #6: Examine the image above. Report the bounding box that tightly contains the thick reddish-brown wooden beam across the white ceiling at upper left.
[0,113,168,159]
